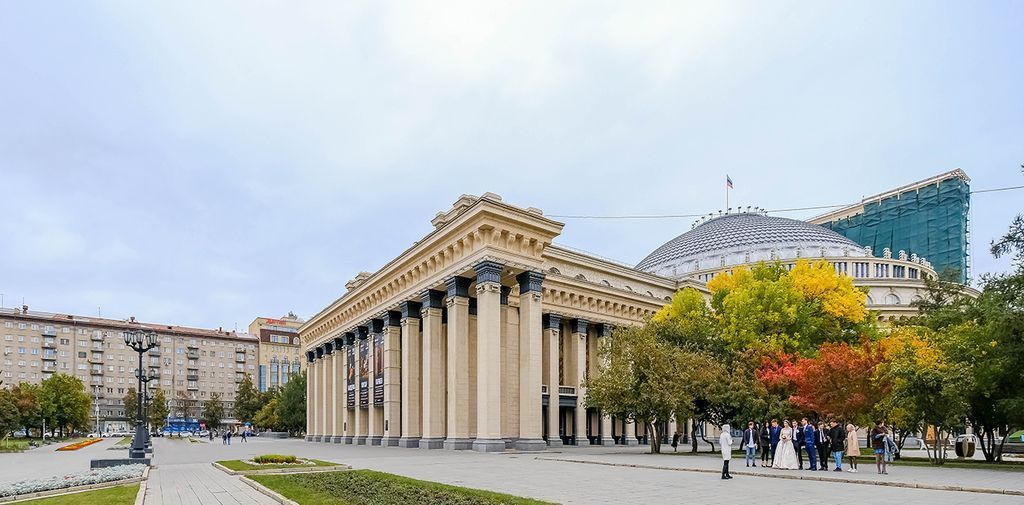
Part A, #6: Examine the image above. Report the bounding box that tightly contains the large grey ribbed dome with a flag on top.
[637,212,869,279]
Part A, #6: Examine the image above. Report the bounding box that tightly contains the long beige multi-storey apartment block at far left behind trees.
[0,306,258,432]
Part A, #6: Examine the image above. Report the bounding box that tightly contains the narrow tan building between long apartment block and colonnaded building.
[249,312,305,391]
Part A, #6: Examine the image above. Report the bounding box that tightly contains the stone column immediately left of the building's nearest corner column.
[444,277,473,450]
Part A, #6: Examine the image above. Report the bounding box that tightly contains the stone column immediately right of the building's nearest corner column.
[515,271,546,451]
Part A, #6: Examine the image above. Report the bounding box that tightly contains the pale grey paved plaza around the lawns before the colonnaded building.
[0,438,1024,505]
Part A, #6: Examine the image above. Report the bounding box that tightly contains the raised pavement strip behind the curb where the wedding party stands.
[538,448,1024,496]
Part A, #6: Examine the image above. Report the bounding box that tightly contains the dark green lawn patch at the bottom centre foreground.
[248,470,549,505]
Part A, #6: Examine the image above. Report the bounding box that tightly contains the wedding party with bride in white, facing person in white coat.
[719,417,894,479]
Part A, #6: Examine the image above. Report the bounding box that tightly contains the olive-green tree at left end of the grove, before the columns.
[585,324,714,454]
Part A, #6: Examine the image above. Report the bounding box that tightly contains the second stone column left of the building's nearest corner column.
[420,290,447,449]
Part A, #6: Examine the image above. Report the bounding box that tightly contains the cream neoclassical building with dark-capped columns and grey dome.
[299,193,954,452]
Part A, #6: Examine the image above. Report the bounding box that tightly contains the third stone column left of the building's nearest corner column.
[398,301,426,448]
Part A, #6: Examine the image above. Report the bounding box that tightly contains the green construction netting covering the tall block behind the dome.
[822,178,971,282]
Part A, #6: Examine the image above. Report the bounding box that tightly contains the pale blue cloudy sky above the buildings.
[0,0,1024,329]
